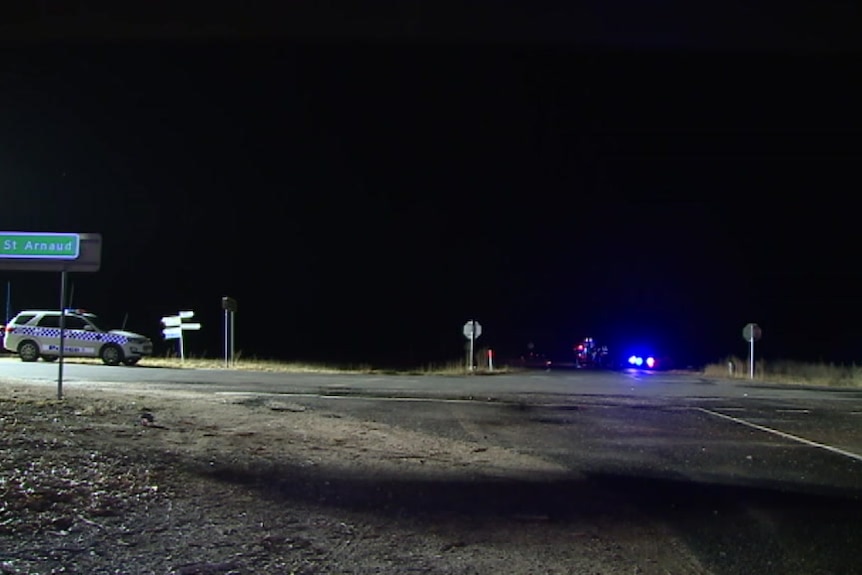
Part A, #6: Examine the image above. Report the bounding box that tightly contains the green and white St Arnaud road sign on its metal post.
[0,232,102,399]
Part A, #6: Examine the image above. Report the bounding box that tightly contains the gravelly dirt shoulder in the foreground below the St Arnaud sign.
[0,381,703,575]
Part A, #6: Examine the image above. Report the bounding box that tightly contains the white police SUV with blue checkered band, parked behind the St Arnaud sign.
[3,310,153,365]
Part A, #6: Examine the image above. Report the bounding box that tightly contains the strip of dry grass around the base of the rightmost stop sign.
[704,357,862,387]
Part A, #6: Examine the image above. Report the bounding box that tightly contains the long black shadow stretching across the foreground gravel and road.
[199,467,862,573]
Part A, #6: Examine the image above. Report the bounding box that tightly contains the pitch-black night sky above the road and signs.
[0,4,862,365]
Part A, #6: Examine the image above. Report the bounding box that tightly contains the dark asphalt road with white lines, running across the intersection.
[5,359,862,574]
